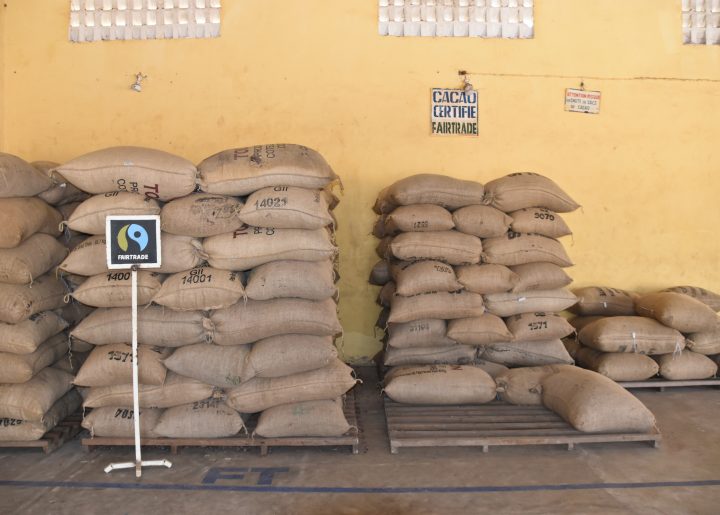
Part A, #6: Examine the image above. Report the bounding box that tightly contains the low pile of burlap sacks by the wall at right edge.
[566,286,720,381]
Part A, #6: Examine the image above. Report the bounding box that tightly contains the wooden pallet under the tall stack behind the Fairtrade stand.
[81,391,360,456]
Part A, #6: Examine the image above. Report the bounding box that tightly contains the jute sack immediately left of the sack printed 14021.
[160,193,243,238]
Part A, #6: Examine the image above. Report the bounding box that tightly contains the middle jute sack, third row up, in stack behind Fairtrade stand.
[163,343,250,388]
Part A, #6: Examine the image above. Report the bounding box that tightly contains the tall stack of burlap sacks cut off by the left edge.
[0,154,82,441]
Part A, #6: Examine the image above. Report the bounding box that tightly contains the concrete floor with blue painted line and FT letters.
[0,368,720,515]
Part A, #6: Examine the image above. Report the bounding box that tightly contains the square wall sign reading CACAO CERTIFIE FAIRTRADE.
[430,88,478,136]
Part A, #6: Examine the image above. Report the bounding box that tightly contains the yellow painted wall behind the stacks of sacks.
[0,0,720,358]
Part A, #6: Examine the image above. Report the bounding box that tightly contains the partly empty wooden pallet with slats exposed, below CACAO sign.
[385,398,661,454]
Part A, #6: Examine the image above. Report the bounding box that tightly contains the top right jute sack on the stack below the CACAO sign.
[485,172,580,213]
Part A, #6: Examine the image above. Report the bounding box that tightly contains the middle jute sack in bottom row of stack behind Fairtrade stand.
[154,399,245,438]
